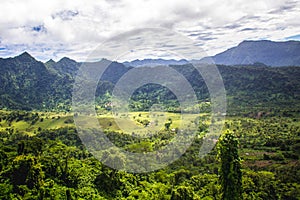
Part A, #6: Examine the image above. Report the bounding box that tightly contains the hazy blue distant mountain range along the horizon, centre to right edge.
[123,40,300,67]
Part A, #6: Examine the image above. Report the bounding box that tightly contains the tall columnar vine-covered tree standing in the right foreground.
[218,130,242,200]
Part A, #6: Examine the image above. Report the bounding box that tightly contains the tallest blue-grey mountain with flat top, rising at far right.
[201,40,300,66]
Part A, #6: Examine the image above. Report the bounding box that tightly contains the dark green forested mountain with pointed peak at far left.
[0,52,71,110]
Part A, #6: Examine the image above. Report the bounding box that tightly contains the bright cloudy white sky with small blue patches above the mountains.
[0,0,300,61]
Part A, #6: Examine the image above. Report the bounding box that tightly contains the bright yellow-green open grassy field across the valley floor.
[0,111,210,135]
